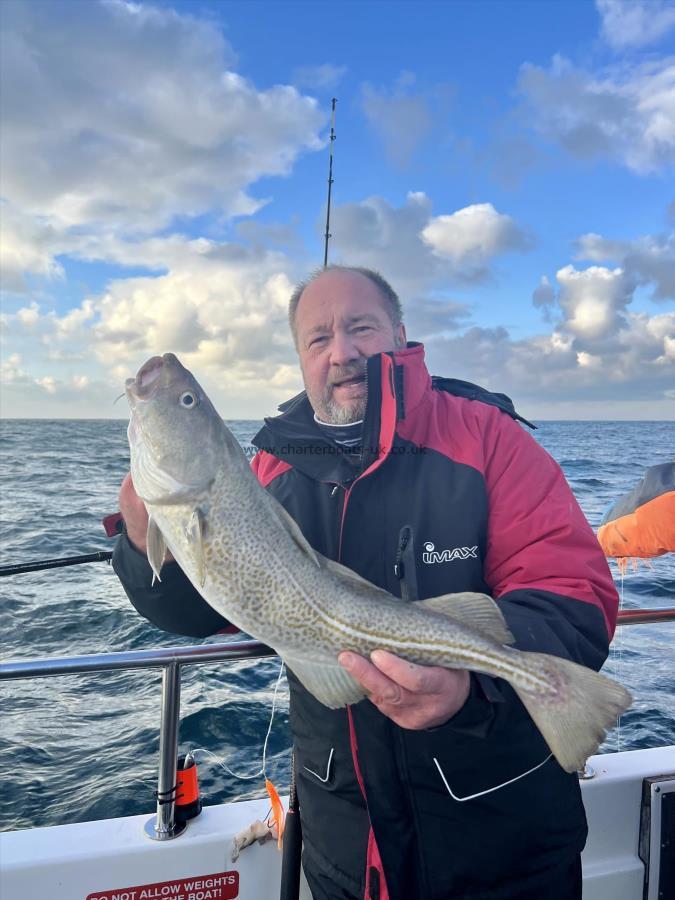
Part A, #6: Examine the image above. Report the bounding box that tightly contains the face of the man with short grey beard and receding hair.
[295,271,405,425]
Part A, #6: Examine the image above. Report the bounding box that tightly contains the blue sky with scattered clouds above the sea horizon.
[0,0,675,419]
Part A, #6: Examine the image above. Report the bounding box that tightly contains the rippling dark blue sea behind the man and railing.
[0,420,675,830]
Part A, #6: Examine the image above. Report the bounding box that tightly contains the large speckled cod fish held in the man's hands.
[126,353,632,772]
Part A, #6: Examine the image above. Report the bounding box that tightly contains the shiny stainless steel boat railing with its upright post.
[0,607,675,841]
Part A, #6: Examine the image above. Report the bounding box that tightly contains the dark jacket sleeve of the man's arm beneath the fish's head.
[112,532,229,637]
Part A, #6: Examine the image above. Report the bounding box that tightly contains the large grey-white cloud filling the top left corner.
[0,0,325,233]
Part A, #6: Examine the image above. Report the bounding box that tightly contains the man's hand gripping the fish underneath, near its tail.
[338,650,470,730]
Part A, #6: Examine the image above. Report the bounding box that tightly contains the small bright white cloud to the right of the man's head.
[422,203,531,272]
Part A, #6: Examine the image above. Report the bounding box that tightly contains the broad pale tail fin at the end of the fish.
[512,653,633,772]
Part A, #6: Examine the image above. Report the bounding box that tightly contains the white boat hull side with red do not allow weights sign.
[0,747,675,900]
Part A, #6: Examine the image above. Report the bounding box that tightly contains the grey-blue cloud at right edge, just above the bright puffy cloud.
[576,232,675,300]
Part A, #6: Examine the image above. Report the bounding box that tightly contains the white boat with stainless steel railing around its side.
[0,608,675,900]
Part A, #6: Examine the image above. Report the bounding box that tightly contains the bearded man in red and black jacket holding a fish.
[114,267,618,900]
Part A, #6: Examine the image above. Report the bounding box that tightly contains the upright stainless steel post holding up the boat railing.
[145,661,187,841]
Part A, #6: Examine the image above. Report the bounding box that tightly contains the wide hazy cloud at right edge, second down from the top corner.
[518,56,675,175]
